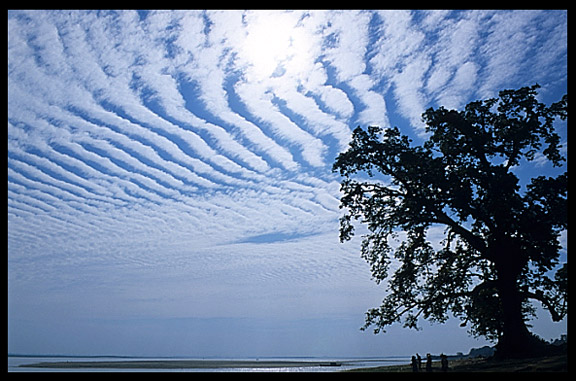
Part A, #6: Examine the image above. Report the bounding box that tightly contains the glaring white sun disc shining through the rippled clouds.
[241,11,309,79]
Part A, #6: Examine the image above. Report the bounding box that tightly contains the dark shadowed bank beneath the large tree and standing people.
[349,354,568,373]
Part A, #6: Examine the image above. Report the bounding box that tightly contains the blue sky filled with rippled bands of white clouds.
[7,10,567,357]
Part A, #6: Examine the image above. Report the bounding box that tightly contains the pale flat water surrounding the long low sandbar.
[8,356,410,373]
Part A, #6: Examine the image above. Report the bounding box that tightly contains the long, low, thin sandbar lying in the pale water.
[20,360,341,369]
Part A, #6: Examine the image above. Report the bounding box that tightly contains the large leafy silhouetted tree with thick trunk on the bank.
[333,85,568,357]
